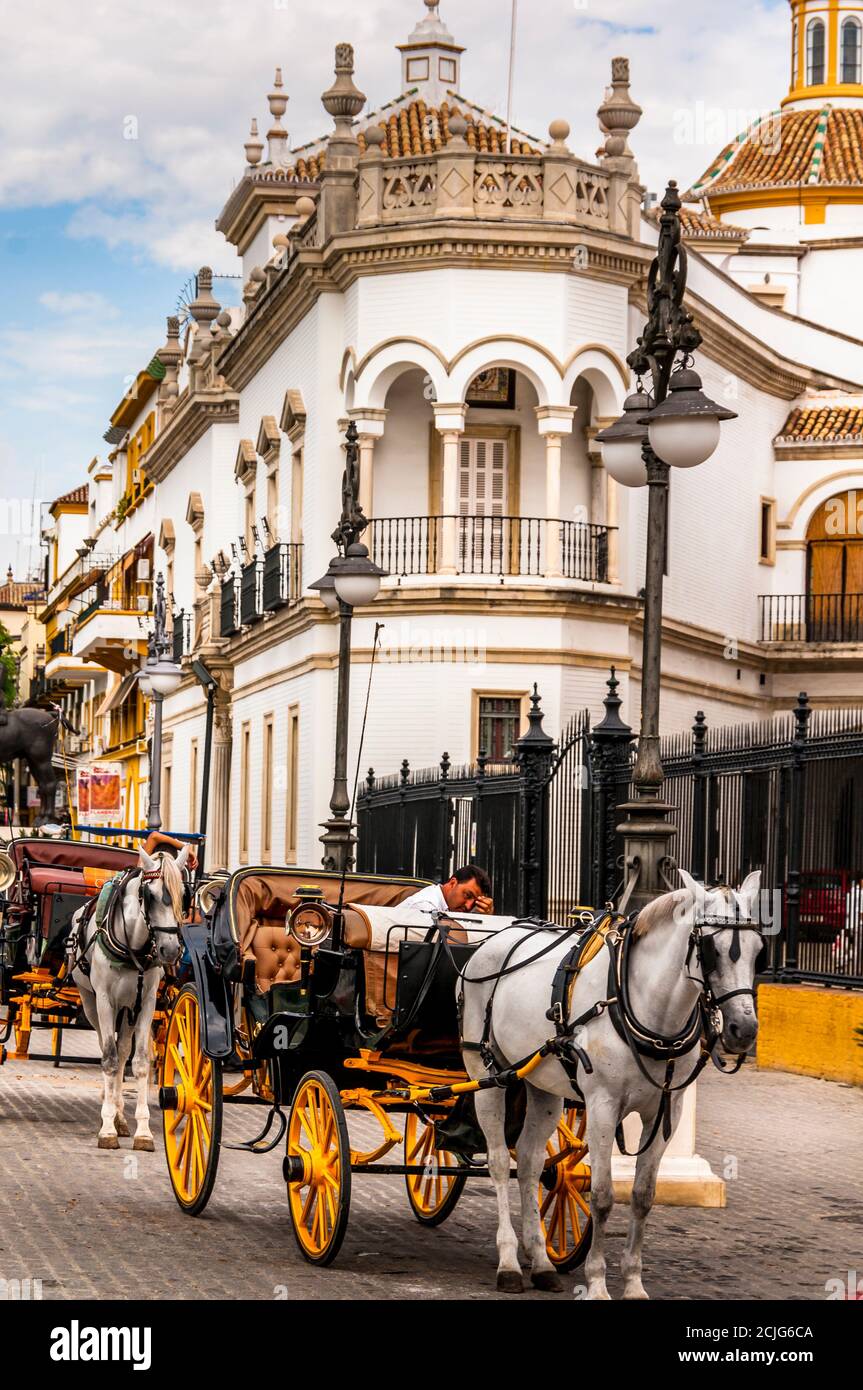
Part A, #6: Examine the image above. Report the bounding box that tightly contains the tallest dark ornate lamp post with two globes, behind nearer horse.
[596,182,737,908]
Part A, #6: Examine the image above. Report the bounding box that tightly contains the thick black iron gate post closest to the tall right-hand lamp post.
[591,667,635,906]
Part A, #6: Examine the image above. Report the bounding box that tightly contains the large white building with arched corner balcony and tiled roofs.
[50,0,863,866]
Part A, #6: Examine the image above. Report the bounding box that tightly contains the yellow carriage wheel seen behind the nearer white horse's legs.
[539,1108,593,1273]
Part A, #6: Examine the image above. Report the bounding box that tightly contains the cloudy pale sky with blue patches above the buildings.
[0,0,789,578]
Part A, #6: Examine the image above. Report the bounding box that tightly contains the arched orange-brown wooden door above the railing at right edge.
[806,488,863,642]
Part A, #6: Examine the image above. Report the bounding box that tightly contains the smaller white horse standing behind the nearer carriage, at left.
[71,847,189,1152]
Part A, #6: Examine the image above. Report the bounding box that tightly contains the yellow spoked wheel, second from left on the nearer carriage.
[285,1072,350,1265]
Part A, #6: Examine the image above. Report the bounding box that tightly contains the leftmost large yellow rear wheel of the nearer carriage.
[160,984,222,1216]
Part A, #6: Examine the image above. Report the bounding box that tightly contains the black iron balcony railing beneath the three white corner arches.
[368,516,616,584]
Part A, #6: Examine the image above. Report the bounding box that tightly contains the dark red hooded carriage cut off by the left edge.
[0,835,184,1066]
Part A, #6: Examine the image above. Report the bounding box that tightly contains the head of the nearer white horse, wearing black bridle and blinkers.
[678,869,764,1055]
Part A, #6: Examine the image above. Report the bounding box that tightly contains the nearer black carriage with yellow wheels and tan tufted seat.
[160,867,591,1269]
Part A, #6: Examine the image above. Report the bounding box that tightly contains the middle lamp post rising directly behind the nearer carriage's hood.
[310,420,386,873]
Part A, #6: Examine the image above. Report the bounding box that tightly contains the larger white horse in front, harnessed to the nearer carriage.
[457,870,763,1300]
